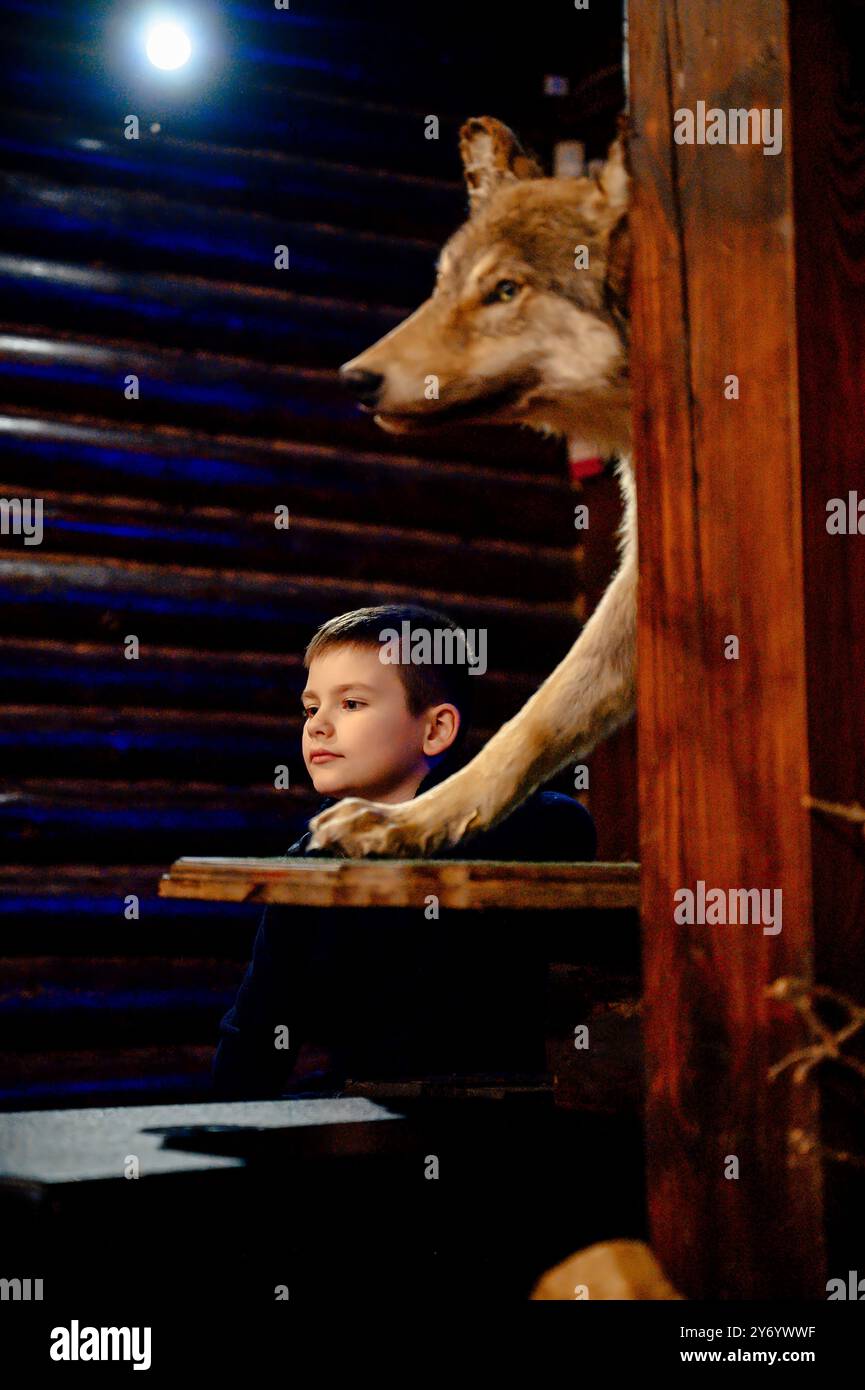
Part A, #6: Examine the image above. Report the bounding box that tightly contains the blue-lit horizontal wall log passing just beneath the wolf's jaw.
[0,407,576,546]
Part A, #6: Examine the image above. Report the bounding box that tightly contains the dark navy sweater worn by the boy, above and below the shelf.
[213,773,597,1099]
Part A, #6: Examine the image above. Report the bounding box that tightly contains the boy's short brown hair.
[303,603,477,765]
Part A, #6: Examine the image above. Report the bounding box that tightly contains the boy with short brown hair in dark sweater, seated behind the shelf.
[213,605,595,1099]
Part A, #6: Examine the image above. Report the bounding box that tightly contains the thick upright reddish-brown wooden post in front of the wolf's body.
[630,0,825,1298]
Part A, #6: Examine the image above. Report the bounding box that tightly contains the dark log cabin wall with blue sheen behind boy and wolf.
[0,0,637,1109]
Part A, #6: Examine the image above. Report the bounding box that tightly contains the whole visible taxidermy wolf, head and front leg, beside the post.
[310,117,637,858]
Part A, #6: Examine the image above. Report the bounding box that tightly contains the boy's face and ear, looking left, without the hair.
[302,646,459,802]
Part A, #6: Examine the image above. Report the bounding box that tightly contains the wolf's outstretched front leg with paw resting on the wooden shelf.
[310,468,637,858]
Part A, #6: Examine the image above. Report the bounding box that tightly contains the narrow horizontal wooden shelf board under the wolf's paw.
[159,858,640,910]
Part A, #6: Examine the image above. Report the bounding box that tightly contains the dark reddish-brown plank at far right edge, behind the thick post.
[790,0,865,1277]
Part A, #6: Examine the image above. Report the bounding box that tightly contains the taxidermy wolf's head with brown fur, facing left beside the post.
[341,115,630,453]
